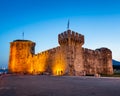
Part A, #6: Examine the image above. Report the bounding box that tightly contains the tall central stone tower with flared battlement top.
[58,30,84,76]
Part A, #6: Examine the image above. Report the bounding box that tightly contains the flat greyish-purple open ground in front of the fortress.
[0,75,120,96]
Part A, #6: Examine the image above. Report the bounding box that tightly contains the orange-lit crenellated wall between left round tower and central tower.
[27,46,67,75]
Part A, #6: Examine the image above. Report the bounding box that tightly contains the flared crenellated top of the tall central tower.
[58,30,84,45]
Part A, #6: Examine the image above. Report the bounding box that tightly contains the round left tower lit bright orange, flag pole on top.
[8,40,35,73]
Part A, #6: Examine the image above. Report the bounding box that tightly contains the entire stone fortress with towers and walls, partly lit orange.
[8,29,113,76]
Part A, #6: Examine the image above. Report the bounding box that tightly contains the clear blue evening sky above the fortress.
[0,0,120,67]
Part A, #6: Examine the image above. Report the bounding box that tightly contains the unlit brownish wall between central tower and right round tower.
[83,48,101,75]
